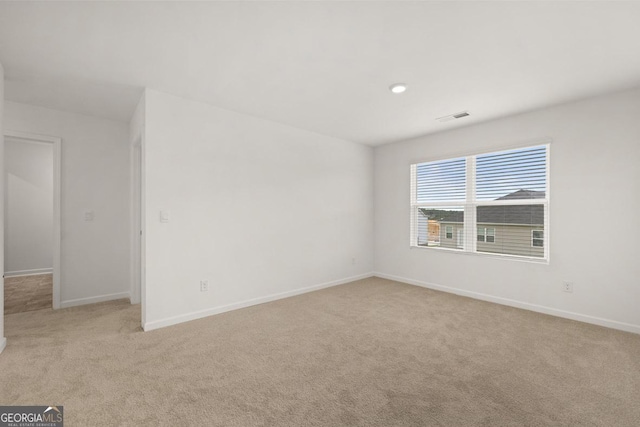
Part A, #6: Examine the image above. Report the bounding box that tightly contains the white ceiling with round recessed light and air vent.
[0,1,640,145]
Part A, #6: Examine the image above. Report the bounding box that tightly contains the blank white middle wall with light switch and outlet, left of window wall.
[143,90,373,330]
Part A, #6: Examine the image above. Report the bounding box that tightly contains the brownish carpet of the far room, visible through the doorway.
[4,274,53,314]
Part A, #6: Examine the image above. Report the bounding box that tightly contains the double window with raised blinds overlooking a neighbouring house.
[411,145,549,259]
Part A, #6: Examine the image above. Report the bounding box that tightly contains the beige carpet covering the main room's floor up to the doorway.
[0,278,640,427]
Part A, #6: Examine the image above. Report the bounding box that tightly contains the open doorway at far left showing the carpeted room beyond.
[3,131,62,315]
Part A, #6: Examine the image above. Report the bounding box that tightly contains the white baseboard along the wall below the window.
[373,272,640,334]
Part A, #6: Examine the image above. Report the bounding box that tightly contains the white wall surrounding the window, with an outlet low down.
[375,90,640,333]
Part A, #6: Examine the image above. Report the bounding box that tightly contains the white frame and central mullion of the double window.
[409,144,552,264]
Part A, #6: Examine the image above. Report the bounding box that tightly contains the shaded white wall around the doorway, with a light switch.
[4,102,130,307]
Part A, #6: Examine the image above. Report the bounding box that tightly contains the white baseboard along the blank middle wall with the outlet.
[142,273,373,331]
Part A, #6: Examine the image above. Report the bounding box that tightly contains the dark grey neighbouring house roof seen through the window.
[420,190,545,225]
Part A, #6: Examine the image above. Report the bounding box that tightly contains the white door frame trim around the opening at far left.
[3,130,62,309]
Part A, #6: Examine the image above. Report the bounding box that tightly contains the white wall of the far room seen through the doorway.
[4,138,53,276]
